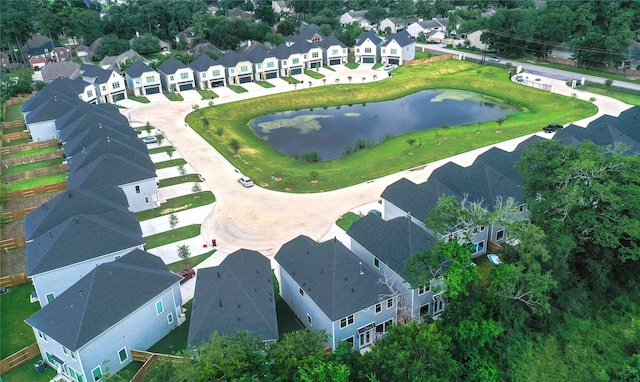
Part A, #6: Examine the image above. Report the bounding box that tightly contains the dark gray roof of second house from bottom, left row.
[26,210,144,276]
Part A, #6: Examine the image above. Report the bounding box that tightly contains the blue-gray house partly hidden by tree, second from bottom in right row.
[347,214,447,321]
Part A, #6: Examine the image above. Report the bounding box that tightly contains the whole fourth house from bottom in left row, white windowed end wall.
[67,154,159,212]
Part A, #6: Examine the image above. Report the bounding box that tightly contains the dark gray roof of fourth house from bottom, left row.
[67,154,156,189]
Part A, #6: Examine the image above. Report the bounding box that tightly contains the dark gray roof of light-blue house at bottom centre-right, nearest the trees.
[275,236,390,321]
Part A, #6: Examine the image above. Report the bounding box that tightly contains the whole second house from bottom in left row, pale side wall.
[26,213,144,306]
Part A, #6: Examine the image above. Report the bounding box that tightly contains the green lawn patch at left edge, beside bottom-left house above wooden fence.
[0,284,40,358]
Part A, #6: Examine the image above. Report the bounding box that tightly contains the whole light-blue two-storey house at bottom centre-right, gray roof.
[275,236,398,350]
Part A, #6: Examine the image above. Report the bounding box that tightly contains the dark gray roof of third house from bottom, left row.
[24,186,130,240]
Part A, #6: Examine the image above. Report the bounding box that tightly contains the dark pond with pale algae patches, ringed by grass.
[249,89,520,161]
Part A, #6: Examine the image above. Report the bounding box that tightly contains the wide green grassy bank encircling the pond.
[187,60,597,193]
